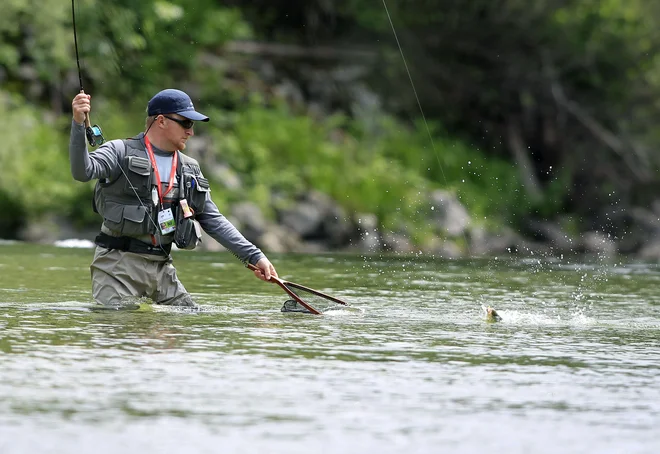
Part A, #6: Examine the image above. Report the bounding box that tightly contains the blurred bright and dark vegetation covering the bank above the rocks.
[0,0,660,245]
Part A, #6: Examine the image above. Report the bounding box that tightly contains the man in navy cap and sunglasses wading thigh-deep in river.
[69,89,277,307]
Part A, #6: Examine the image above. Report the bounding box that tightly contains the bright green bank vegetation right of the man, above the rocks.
[210,102,521,239]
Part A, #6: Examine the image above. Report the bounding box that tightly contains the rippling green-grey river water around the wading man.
[0,244,660,454]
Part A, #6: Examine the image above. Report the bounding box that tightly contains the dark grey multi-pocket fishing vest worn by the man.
[94,134,209,237]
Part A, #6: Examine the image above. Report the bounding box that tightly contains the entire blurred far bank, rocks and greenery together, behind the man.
[0,0,660,259]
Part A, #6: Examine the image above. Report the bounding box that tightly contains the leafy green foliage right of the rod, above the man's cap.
[80,0,252,97]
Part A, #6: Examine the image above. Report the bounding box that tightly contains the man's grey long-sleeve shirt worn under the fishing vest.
[69,121,265,265]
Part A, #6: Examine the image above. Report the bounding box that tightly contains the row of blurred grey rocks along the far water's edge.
[10,186,660,261]
